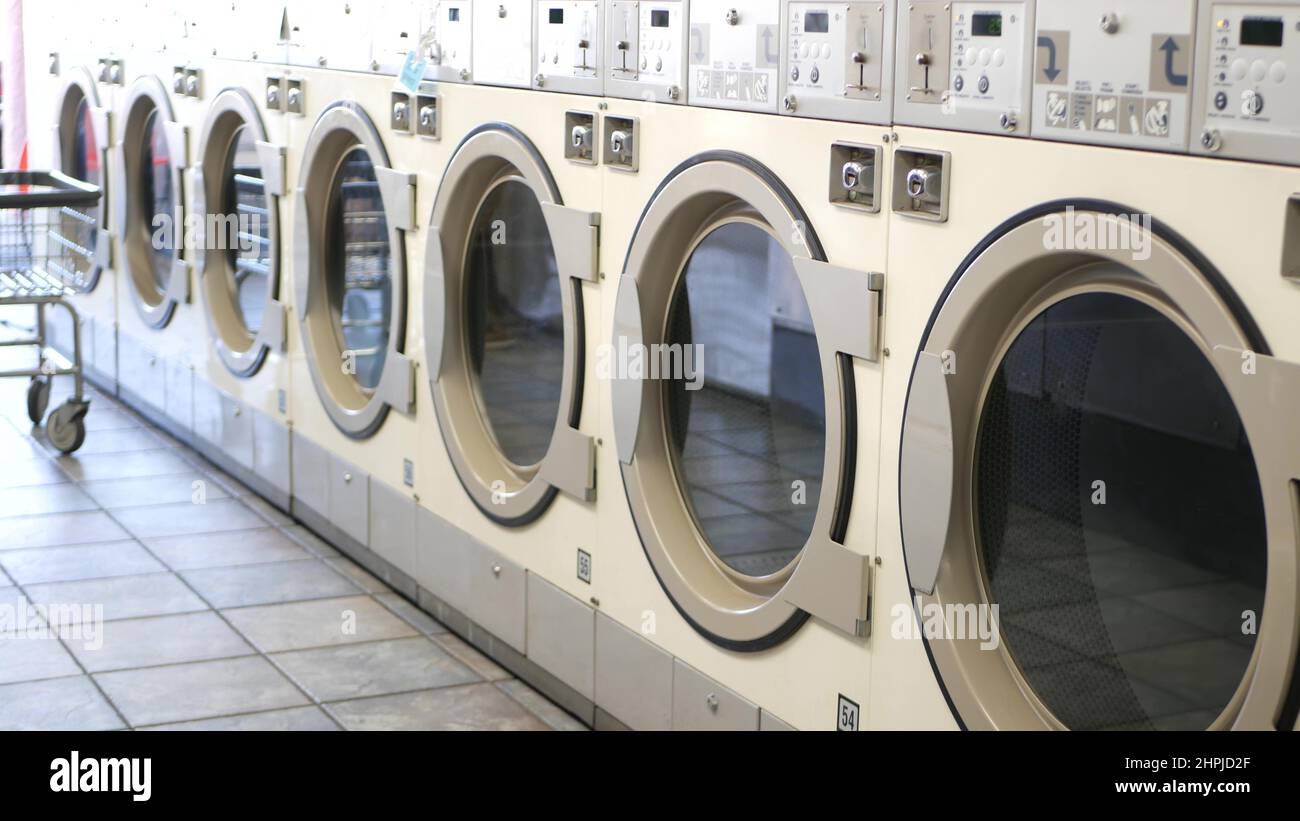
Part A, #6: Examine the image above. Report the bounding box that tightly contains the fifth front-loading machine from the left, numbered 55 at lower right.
[417,3,602,721]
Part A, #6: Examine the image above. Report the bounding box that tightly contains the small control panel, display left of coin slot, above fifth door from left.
[533,0,603,95]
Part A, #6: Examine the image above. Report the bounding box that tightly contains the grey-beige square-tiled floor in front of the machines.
[0,319,581,730]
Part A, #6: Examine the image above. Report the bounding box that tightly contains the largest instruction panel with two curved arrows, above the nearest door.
[1032,0,1196,151]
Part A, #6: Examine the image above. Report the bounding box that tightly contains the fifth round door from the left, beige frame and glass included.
[424,123,595,526]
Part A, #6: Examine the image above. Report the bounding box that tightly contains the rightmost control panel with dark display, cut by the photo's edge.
[1191,0,1300,165]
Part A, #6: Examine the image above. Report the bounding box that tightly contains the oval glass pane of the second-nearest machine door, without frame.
[662,222,826,577]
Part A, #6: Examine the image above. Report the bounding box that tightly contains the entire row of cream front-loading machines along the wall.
[17,0,1300,729]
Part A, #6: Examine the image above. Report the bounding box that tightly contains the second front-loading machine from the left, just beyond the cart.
[111,3,208,439]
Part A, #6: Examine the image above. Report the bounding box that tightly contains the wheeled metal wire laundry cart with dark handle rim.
[0,171,100,453]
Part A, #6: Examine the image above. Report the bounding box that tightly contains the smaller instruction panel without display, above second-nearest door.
[686,0,781,113]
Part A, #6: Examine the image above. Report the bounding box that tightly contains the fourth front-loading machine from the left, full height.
[273,33,437,589]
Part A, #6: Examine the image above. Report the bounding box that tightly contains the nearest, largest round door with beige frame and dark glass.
[901,205,1294,730]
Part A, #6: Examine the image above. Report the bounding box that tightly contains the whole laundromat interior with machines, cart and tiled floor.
[0,0,1300,731]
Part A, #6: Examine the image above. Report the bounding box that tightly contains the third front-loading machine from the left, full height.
[190,43,293,508]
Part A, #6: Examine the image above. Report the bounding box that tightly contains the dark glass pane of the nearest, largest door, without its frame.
[974,291,1268,730]
